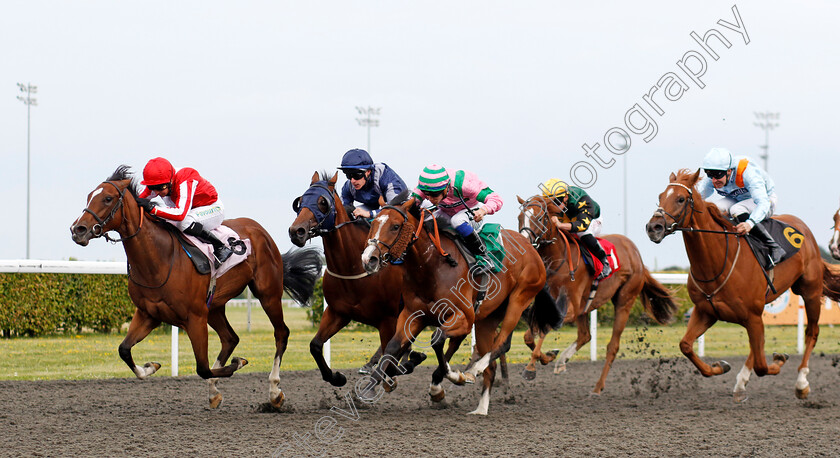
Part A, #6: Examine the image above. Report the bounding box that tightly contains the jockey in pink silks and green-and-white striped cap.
[414,164,503,273]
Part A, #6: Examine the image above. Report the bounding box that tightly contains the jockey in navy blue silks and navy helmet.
[338,149,408,218]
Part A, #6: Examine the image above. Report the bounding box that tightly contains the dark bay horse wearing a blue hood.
[289,172,426,386]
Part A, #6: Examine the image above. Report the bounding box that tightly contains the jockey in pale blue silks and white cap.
[697,148,785,265]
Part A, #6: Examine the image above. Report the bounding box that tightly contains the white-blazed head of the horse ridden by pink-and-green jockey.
[362,191,420,273]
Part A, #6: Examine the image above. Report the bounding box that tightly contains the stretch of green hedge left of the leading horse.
[0,274,134,337]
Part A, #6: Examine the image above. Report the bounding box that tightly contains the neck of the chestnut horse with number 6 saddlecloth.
[683,207,740,279]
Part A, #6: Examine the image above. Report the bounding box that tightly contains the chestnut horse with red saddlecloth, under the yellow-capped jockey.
[517,196,677,395]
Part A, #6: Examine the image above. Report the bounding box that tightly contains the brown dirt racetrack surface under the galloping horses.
[0,353,840,457]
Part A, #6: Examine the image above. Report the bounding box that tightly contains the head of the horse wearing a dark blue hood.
[289,172,344,247]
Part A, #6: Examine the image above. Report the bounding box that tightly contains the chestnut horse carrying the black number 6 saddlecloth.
[646,169,840,402]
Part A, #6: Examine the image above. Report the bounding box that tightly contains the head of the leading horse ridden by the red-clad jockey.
[70,165,139,246]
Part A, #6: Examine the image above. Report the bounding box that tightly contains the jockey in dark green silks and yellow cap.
[540,178,612,281]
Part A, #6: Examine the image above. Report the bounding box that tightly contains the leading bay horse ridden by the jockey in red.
[70,165,321,408]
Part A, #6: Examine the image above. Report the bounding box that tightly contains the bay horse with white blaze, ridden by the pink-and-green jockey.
[361,198,553,415]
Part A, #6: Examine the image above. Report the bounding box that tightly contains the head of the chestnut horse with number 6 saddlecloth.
[645,169,703,243]
